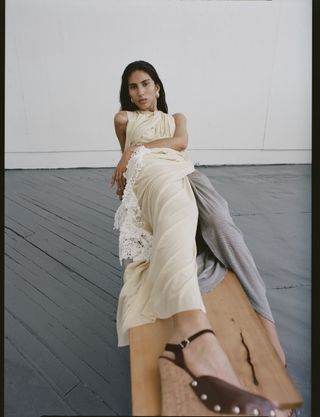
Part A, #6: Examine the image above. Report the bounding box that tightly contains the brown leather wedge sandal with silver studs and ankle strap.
[159,329,276,417]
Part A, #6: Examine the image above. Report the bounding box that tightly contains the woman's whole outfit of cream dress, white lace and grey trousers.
[114,111,274,346]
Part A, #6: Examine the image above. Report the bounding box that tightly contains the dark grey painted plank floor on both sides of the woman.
[5,165,311,417]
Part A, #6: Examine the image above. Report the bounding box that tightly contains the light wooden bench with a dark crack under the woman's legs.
[129,271,303,416]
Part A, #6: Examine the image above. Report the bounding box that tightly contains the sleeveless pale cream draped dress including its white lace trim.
[115,111,206,346]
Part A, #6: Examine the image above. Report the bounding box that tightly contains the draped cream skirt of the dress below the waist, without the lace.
[117,148,206,346]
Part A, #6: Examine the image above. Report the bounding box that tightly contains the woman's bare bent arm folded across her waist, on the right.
[124,113,188,156]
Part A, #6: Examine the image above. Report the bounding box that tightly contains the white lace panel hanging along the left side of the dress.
[114,146,152,264]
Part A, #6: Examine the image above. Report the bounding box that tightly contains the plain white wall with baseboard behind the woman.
[5,0,311,168]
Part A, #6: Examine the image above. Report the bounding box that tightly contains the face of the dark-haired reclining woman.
[128,70,160,111]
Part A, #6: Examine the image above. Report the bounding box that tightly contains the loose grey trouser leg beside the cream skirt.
[188,170,274,322]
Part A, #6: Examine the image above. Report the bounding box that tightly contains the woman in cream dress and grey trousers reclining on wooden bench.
[111,61,296,417]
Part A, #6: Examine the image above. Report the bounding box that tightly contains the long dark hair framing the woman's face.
[120,61,168,113]
